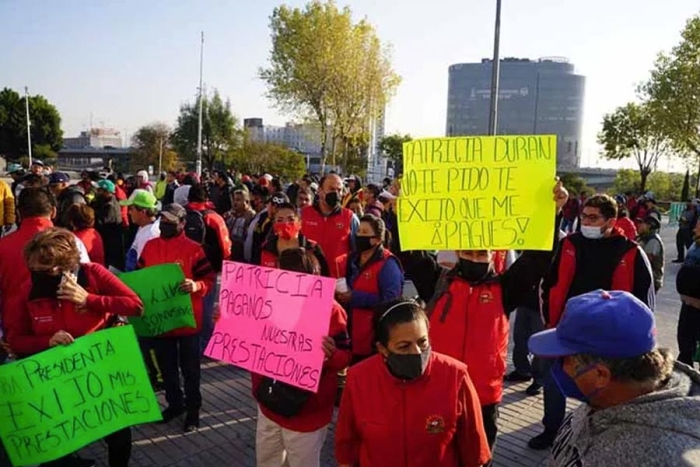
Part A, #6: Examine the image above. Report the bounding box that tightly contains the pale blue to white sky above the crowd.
[0,0,700,170]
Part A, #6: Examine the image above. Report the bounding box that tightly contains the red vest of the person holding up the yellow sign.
[430,277,510,405]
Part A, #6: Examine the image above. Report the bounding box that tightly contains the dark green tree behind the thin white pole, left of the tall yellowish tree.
[171,91,243,170]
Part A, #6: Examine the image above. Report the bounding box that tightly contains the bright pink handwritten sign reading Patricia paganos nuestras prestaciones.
[205,261,335,392]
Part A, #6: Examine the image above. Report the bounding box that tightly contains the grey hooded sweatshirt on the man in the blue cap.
[551,363,700,467]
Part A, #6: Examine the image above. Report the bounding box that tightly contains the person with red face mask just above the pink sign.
[260,203,330,277]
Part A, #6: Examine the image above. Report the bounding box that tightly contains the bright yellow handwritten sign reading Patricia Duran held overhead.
[397,135,557,251]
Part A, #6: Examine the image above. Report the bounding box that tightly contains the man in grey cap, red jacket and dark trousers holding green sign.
[137,203,215,432]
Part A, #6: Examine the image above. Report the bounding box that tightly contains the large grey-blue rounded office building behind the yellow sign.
[446,58,586,168]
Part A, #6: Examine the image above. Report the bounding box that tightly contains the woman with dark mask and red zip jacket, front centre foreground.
[335,300,491,467]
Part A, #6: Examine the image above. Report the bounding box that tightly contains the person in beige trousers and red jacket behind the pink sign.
[251,248,351,467]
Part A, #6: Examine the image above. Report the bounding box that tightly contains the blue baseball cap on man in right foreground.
[528,290,656,358]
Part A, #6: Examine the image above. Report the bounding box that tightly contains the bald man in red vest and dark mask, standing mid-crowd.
[301,174,360,278]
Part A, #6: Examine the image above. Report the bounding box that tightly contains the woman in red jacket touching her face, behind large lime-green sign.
[3,228,143,467]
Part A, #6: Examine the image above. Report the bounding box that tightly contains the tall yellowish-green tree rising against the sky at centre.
[259,1,400,172]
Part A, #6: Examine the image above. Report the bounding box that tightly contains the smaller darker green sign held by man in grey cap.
[119,263,197,337]
